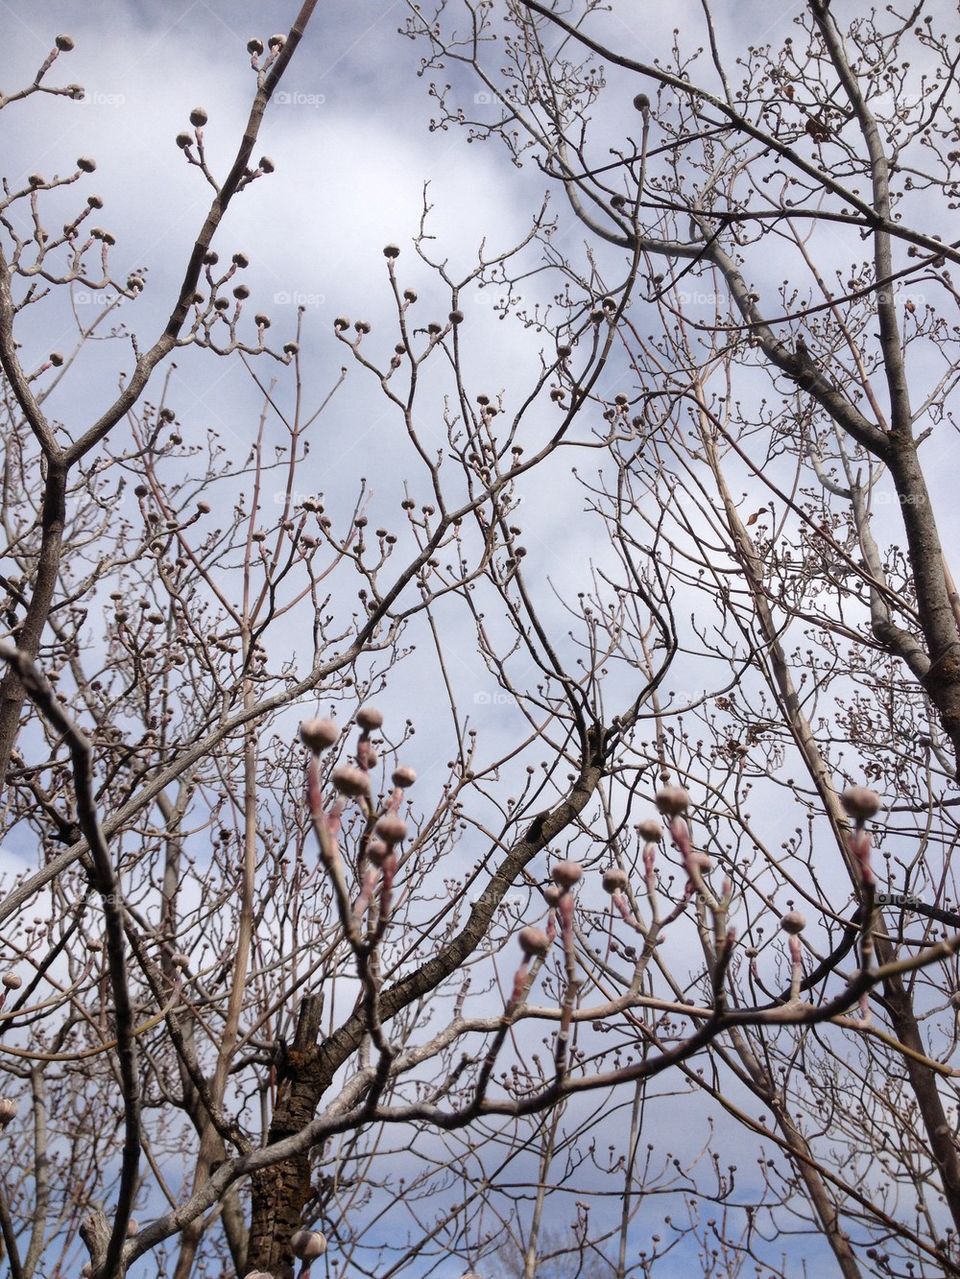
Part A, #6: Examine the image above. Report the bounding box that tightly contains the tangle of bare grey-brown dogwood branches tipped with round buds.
[0,7,960,1279]
